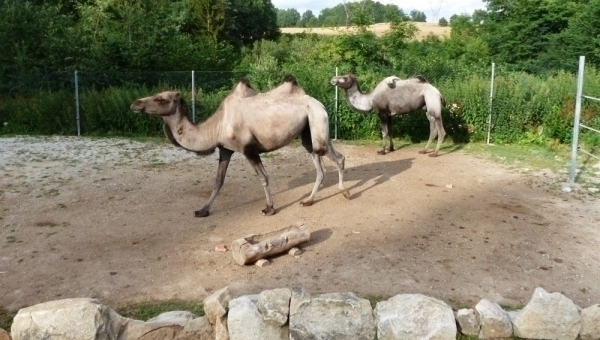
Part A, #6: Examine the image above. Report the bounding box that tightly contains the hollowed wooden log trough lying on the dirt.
[231,224,310,265]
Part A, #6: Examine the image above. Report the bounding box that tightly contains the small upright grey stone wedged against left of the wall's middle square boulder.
[256,288,292,326]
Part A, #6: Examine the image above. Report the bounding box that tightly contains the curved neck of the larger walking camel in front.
[164,110,217,153]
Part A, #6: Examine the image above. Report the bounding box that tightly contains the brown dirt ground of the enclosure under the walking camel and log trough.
[0,137,600,310]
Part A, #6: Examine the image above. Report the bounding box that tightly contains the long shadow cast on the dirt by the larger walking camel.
[277,156,414,211]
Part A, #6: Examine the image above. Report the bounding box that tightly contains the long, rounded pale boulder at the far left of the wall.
[11,299,126,340]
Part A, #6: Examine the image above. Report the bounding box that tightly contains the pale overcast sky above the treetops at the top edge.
[271,0,485,23]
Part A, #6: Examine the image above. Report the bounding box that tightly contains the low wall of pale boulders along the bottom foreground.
[0,288,600,340]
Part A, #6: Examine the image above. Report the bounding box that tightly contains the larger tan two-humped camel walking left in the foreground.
[131,75,350,217]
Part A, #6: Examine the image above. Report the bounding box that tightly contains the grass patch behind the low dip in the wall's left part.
[116,300,204,321]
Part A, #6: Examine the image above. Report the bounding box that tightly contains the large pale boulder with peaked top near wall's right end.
[512,288,581,340]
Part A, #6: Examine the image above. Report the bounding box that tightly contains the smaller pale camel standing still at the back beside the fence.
[331,74,446,157]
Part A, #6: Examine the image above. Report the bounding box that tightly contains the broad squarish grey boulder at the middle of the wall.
[290,289,375,340]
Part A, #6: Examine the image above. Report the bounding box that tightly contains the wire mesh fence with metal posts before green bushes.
[0,62,600,147]
